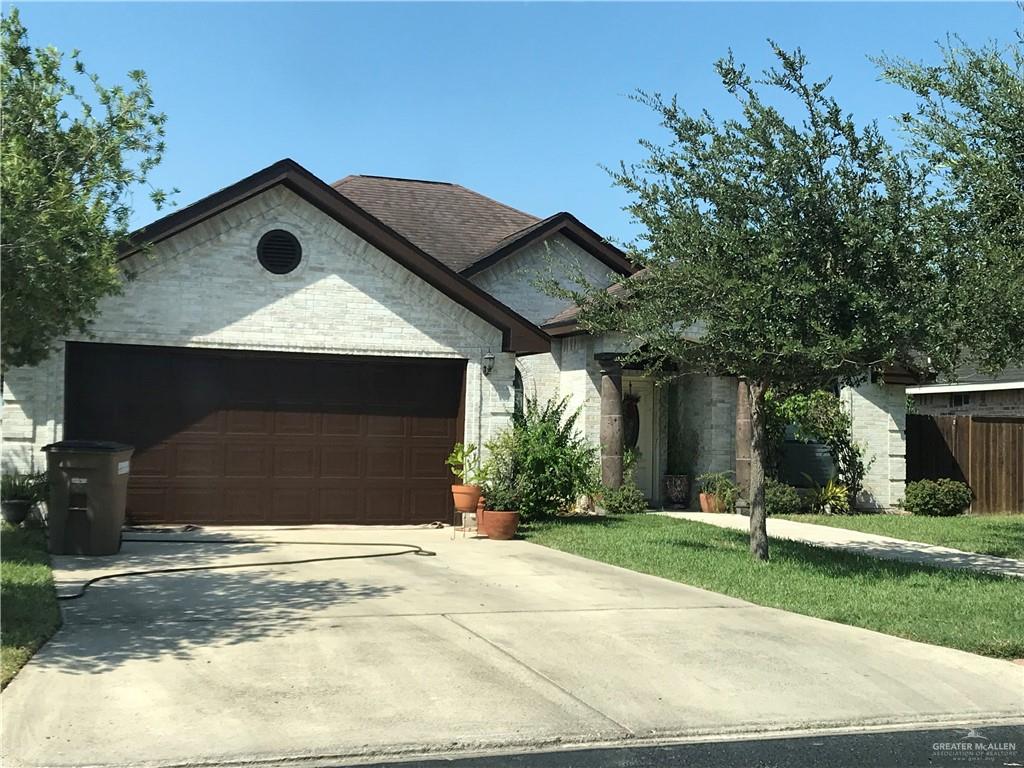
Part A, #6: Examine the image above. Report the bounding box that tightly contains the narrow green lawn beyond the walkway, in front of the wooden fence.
[783,515,1024,559]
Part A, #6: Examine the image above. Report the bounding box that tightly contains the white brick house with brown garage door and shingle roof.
[3,160,905,523]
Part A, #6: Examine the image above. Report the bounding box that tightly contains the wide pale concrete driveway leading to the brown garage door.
[0,527,1024,766]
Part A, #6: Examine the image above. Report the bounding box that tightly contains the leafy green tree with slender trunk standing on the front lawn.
[574,44,937,559]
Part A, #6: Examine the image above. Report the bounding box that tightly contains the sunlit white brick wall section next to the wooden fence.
[841,383,906,510]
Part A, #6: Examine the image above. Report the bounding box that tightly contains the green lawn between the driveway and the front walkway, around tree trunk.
[523,515,1024,658]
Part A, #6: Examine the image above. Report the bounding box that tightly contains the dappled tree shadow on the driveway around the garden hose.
[44,542,410,674]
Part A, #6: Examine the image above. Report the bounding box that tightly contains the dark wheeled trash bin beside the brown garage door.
[43,440,135,555]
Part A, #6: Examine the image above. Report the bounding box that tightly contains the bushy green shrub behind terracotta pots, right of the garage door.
[483,398,598,519]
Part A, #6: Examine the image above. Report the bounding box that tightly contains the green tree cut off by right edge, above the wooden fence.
[877,33,1024,372]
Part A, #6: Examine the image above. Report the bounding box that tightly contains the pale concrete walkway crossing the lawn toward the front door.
[653,512,1024,578]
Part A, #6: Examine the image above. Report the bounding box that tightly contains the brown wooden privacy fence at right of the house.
[906,414,1024,514]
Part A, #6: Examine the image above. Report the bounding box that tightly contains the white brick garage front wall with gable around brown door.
[3,187,514,475]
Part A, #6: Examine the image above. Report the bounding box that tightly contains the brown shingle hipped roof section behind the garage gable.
[332,176,540,272]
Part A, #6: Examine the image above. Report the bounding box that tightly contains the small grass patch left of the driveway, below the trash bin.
[0,523,60,688]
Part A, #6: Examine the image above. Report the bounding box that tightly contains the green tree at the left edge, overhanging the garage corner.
[0,8,173,370]
